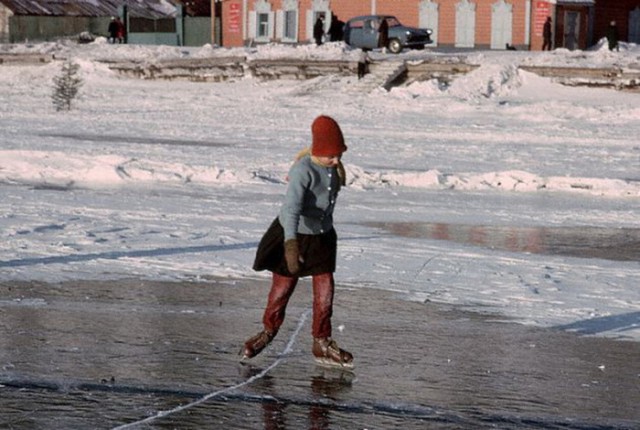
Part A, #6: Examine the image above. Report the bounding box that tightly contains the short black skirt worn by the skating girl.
[253,218,338,277]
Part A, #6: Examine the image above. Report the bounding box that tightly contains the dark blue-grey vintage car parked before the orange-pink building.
[344,15,432,54]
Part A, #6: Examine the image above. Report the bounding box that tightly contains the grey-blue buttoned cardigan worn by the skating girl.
[279,155,340,241]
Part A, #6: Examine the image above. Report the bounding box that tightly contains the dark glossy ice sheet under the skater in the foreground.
[0,278,640,430]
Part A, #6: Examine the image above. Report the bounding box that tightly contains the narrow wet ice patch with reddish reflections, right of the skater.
[364,222,640,261]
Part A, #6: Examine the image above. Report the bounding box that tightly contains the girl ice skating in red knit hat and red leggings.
[241,115,353,368]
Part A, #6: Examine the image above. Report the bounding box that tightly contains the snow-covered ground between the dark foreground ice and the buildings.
[0,40,640,341]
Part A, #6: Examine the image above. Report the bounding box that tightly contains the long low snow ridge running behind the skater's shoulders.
[0,151,640,197]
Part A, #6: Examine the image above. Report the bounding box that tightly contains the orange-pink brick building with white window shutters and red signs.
[211,0,640,50]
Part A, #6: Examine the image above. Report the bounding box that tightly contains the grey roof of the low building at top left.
[0,0,176,19]
